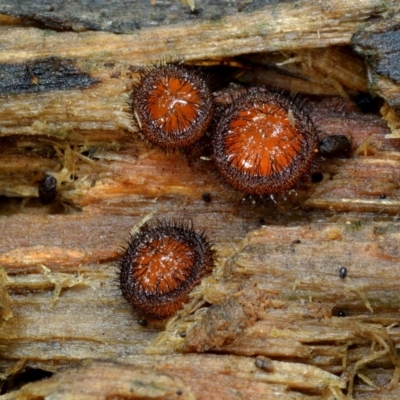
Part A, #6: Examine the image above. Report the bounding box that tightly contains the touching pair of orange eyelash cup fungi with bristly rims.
[133,64,318,195]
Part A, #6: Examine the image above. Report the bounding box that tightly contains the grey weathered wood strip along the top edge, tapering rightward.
[0,0,296,33]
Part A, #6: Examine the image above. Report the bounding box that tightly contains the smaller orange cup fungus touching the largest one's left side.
[132,64,214,149]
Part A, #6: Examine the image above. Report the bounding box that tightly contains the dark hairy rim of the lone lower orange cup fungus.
[119,220,215,319]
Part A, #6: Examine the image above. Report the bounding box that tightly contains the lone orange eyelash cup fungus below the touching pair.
[119,220,215,319]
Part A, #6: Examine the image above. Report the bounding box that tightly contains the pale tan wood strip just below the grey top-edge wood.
[1,0,399,65]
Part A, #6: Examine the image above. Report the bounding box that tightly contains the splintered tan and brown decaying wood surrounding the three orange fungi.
[0,0,400,400]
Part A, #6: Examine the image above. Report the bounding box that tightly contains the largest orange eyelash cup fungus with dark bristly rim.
[213,87,318,195]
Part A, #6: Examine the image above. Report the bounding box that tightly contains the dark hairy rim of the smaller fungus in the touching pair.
[132,64,214,150]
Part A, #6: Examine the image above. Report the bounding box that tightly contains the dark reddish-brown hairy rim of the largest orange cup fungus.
[213,87,318,195]
